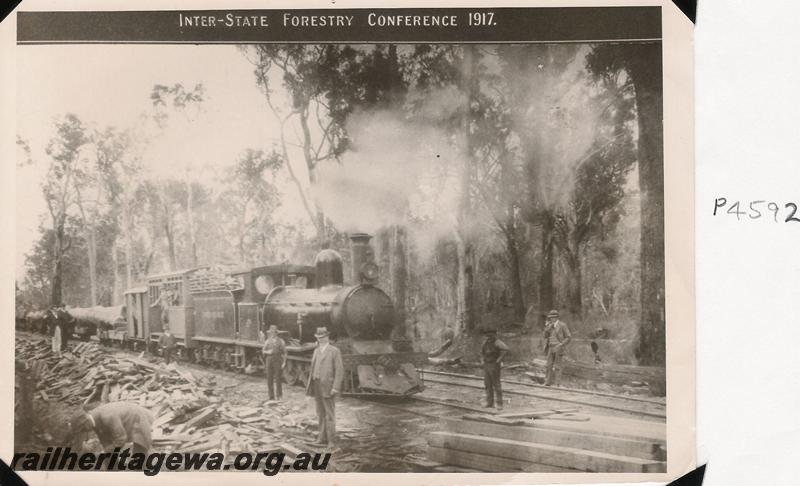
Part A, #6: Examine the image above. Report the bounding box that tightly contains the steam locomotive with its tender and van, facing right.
[116,233,427,395]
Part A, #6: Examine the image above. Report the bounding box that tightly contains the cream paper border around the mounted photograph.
[0,0,696,486]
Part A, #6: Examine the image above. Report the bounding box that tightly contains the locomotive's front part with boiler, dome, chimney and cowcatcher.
[262,234,427,395]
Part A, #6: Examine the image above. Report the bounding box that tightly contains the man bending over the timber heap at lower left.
[68,402,153,454]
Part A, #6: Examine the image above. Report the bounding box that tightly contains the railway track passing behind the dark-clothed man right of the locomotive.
[420,369,666,421]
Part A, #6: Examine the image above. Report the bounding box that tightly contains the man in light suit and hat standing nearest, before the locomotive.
[306,327,344,447]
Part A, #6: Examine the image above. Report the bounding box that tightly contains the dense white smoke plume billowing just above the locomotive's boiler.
[314,105,460,243]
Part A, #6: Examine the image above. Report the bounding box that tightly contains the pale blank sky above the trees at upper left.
[15,45,310,278]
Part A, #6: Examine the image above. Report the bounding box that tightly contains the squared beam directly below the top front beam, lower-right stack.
[428,432,666,473]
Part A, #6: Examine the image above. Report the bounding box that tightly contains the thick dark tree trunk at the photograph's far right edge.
[629,44,666,365]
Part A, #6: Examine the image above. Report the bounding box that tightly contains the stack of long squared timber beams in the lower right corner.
[428,410,666,473]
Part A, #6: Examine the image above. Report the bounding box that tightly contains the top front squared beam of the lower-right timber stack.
[443,419,666,461]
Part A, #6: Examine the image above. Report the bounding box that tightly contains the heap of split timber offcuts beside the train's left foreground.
[16,339,317,457]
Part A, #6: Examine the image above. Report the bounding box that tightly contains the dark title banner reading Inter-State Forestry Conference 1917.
[17,7,661,44]
